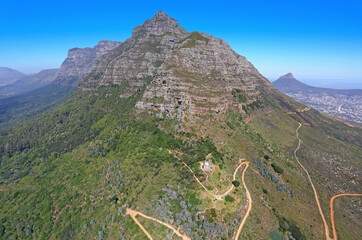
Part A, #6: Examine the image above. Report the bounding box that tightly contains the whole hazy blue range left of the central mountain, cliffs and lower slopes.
[0,40,119,128]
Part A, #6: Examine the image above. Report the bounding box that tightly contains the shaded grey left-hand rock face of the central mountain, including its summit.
[82,12,187,92]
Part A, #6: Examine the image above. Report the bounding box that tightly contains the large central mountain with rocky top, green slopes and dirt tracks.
[0,11,362,240]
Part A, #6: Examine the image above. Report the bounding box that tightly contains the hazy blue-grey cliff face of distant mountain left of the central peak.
[55,40,120,84]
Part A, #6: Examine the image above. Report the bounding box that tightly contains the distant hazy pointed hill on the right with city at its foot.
[273,73,362,123]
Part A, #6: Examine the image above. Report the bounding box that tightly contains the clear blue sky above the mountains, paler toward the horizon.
[0,0,362,88]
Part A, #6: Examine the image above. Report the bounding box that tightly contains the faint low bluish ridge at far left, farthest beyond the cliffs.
[0,69,58,98]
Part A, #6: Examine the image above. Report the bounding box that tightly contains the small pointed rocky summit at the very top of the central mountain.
[132,11,187,38]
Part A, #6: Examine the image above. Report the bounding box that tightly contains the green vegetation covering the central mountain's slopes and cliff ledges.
[0,15,361,239]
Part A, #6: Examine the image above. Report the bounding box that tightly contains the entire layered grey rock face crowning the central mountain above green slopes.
[82,12,271,120]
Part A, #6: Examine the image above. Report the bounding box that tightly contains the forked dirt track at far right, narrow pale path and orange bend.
[294,124,362,240]
